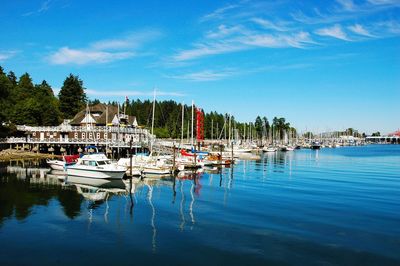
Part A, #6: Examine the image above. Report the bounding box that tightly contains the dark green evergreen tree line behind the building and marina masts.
[0,66,296,139]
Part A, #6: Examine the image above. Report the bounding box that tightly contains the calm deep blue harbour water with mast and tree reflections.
[0,145,400,266]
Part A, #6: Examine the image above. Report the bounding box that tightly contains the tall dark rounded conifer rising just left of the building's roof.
[58,74,86,119]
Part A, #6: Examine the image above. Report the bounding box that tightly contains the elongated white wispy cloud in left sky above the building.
[47,31,160,65]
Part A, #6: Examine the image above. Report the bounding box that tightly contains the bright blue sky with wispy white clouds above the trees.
[0,0,400,133]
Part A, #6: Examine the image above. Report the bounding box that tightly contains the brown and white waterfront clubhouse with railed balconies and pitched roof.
[8,104,154,152]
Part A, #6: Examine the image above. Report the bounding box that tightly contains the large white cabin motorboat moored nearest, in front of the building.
[67,153,126,179]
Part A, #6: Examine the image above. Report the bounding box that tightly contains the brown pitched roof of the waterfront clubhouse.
[70,103,136,126]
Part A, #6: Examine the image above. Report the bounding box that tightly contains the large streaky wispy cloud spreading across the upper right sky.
[165,0,400,66]
